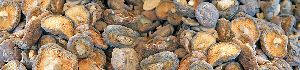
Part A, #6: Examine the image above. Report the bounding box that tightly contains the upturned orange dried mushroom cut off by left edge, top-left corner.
[0,1,21,31]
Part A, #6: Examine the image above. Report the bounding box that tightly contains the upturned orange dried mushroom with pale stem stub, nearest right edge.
[260,30,288,58]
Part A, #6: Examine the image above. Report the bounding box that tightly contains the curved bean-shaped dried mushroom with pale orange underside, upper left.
[41,15,74,39]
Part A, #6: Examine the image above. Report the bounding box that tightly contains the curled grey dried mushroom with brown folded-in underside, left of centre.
[102,25,139,48]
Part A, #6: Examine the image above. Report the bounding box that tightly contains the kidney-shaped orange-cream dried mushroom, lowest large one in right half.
[207,42,241,66]
